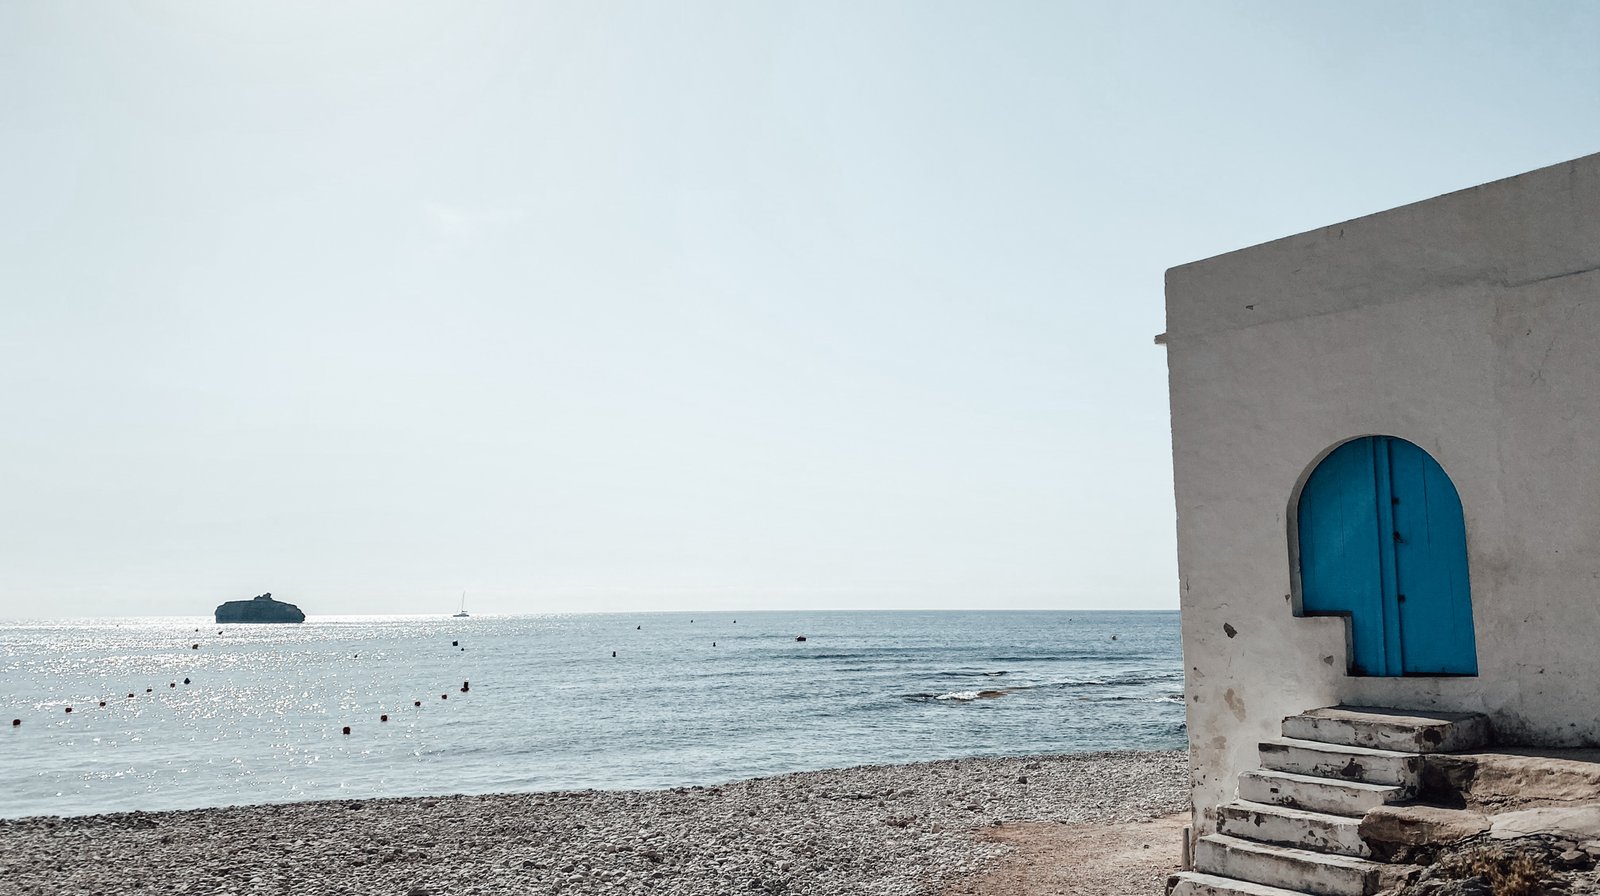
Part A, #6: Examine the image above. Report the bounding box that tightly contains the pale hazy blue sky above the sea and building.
[0,0,1600,616]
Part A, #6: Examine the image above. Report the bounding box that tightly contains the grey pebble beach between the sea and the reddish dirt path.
[0,752,1187,896]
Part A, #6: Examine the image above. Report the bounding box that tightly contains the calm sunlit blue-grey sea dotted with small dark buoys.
[0,611,1186,818]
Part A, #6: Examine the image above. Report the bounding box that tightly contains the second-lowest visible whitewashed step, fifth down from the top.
[1194,834,1408,896]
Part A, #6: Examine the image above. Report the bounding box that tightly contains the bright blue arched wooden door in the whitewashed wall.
[1296,435,1478,675]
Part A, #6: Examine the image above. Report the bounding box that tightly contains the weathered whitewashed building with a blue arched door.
[1165,155,1600,834]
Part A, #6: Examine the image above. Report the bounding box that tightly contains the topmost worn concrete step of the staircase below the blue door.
[1283,706,1490,754]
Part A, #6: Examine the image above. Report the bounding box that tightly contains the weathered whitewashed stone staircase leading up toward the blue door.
[1168,706,1488,896]
